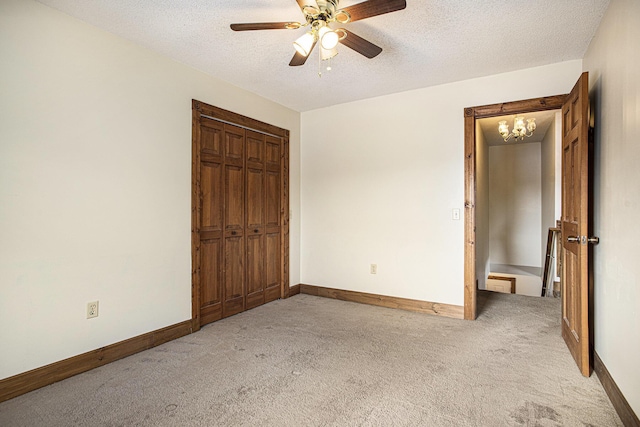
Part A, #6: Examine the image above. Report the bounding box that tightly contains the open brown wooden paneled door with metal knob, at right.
[562,73,597,376]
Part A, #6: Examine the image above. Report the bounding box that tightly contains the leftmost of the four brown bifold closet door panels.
[199,119,224,324]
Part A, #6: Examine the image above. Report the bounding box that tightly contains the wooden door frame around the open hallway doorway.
[464,94,567,320]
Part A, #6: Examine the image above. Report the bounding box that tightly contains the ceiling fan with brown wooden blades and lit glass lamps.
[231,0,407,67]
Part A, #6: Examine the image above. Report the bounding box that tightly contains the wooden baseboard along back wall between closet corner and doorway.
[300,284,464,319]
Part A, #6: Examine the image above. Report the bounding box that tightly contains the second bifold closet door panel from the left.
[222,124,245,317]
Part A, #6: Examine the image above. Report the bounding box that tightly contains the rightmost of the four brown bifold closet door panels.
[264,136,283,302]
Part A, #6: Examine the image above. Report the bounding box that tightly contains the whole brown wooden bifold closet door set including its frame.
[192,101,288,329]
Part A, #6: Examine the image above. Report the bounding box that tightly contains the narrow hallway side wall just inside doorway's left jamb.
[476,121,491,289]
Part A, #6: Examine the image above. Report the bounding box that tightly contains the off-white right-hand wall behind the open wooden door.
[583,0,640,414]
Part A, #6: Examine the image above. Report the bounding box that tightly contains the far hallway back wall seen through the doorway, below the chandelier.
[489,142,542,267]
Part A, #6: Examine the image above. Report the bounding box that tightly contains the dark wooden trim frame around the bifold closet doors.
[191,99,289,332]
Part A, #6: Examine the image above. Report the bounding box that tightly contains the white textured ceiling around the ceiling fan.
[39,0,609,111]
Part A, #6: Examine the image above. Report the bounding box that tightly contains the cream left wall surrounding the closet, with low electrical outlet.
[0,0,300,378]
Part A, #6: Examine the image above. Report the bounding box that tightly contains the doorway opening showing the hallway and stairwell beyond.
[476,110,562,297]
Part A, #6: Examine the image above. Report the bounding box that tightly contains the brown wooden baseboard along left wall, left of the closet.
[0,320,192,402]
